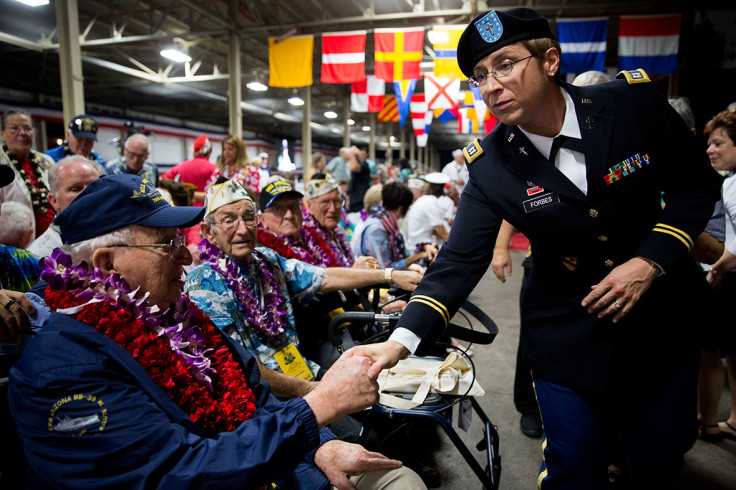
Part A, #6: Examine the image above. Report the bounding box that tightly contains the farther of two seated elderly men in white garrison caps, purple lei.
[303,174,373,268]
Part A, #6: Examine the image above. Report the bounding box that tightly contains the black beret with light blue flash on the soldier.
[457,8,555,77]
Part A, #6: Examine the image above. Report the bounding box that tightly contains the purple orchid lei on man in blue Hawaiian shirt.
[197,239,287,347]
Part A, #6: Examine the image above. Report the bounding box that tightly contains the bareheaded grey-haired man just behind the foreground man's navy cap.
[28,155,100,257]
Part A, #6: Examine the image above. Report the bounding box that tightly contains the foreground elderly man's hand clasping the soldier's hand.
[304,353,378,427]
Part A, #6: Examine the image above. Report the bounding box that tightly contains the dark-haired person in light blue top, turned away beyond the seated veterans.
[352,182,437,269]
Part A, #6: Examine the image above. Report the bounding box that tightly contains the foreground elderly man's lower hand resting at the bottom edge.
[314,439,401,490]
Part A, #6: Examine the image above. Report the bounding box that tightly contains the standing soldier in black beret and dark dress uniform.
[348,8,721,489]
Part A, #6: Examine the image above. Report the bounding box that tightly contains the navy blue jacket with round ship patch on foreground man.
[9,313,335,489]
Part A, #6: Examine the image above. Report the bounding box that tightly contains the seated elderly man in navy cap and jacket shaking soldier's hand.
[9,175,422,489]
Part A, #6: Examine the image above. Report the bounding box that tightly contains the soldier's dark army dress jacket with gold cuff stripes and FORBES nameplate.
[397,80,721,392]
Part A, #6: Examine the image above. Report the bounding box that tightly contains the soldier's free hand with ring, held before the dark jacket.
[581,257,660,323]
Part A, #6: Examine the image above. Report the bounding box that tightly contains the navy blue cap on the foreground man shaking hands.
[54,174,204,243]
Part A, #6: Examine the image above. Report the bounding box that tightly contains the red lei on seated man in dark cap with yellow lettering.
[258,223,340,267]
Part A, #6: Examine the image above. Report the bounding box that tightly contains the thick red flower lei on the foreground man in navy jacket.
[46,286,256,437]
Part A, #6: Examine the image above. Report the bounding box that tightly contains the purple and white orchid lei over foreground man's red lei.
[39,248,215,391]
